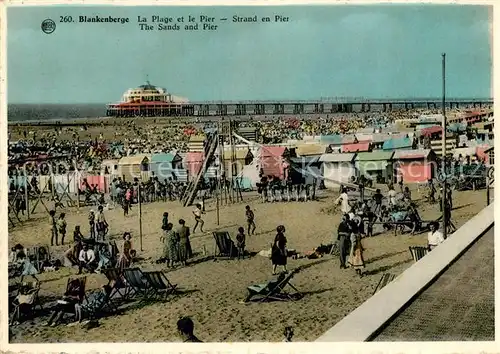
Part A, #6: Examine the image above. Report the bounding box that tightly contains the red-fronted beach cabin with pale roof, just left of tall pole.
[393,149,436,183]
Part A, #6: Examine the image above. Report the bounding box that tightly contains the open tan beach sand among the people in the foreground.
[9,190,485,343]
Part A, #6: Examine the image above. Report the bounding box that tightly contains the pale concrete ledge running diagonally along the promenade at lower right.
[316,204,494,342]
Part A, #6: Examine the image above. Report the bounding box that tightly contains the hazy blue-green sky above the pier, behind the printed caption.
[7,4,492,103]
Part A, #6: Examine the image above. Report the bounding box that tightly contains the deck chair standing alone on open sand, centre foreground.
[245,269,302,302]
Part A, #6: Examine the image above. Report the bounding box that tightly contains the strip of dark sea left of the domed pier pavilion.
[7,103,106,122]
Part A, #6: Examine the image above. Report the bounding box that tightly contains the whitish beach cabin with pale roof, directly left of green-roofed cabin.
[319,153,357,189]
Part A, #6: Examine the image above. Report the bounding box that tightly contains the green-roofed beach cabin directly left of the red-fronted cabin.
[355,151,394,182]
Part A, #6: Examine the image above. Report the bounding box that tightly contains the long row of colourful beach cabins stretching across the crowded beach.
[12,128,494,193]
